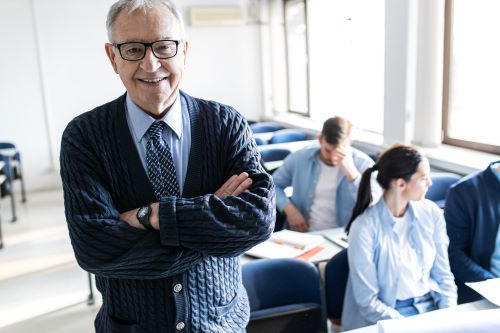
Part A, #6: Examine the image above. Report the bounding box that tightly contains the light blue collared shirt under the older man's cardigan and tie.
[126,94,191,193]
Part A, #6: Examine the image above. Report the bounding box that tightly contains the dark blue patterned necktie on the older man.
[146,121,180,199]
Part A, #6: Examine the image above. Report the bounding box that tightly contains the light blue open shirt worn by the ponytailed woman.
[342,199,457,329]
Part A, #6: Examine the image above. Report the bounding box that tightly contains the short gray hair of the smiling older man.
[106,0,186,42]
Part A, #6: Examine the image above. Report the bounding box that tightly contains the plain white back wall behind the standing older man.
[0,0,263,190]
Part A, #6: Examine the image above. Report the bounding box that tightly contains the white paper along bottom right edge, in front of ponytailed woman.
[378,309,500,333]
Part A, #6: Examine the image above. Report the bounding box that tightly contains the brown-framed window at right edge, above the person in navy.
[443,0,500,154]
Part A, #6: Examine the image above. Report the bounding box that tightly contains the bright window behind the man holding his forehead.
[285,0,385,133]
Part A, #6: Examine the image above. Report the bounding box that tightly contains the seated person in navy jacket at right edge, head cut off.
[444,161,500,303]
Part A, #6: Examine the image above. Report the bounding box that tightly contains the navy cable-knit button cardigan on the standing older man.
[60,93,275,332]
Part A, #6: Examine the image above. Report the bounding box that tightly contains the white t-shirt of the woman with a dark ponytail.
[393,213,430,300]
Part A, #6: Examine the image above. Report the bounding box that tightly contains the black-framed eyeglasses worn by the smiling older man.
[113,39,181,61]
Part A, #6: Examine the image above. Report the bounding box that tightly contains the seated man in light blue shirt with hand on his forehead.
[273,117,380,232]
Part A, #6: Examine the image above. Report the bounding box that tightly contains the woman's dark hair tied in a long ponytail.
[345,144,423,233]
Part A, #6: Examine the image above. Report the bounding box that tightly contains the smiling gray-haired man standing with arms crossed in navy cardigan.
[61,0,275,332]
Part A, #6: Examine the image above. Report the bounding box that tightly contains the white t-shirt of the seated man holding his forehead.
[309,157,340,231]
